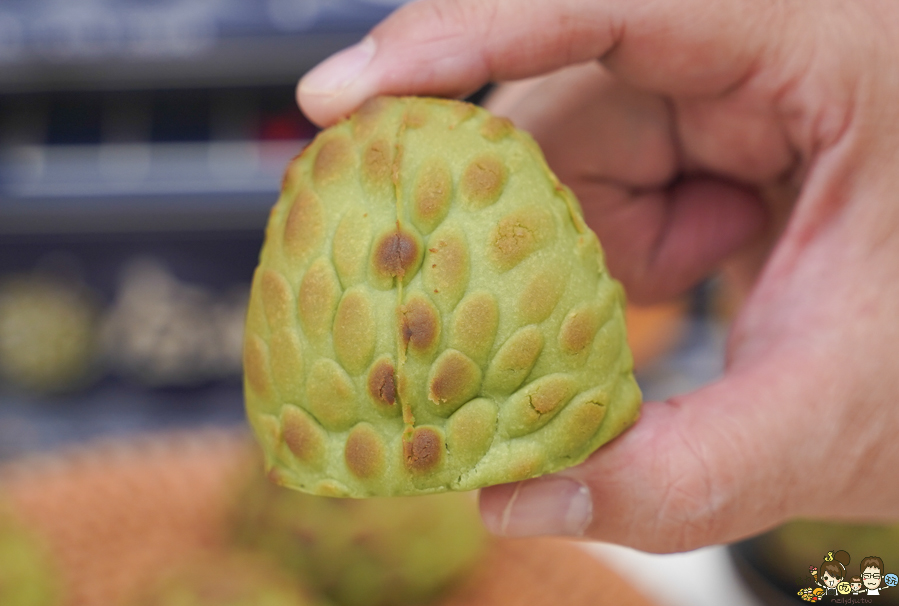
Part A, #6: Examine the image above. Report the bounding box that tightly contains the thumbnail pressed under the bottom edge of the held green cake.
[487,476,593,537]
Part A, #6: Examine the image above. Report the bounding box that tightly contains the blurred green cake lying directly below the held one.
[234,474,487,606]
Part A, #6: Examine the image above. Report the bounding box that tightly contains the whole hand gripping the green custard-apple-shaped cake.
[298,0,899,552]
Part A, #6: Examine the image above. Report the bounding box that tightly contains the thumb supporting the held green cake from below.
[481,358,806,552]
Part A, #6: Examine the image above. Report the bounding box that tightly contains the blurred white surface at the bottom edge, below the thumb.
[584,543,763,606]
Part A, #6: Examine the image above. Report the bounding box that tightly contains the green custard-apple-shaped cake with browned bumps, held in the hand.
[244,97,641,497]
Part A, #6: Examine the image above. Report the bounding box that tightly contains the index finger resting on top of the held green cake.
[297,0,779,126]
